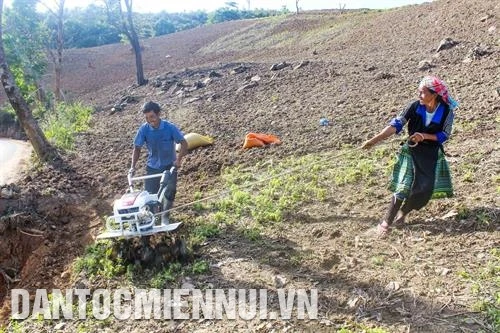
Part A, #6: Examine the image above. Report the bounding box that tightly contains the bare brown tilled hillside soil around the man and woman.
[0,0,500,332]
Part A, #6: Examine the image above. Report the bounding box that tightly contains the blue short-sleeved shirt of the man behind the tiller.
[134,120,184,169]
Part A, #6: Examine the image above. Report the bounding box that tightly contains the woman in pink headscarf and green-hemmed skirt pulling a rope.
[361,76,458,236]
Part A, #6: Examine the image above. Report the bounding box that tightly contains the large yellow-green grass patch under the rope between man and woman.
[188,146,391,246]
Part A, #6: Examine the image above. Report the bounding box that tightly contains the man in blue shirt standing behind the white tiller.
[129,102,188,220]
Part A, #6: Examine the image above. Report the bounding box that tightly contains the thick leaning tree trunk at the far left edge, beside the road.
[0,0,57,162]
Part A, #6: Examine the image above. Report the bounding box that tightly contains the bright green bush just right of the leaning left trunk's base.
[41,103,92,150]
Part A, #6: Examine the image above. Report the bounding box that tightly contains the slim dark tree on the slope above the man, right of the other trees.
[103,0,147,86]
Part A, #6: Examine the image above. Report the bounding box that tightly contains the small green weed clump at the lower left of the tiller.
[74,241,126,279]
